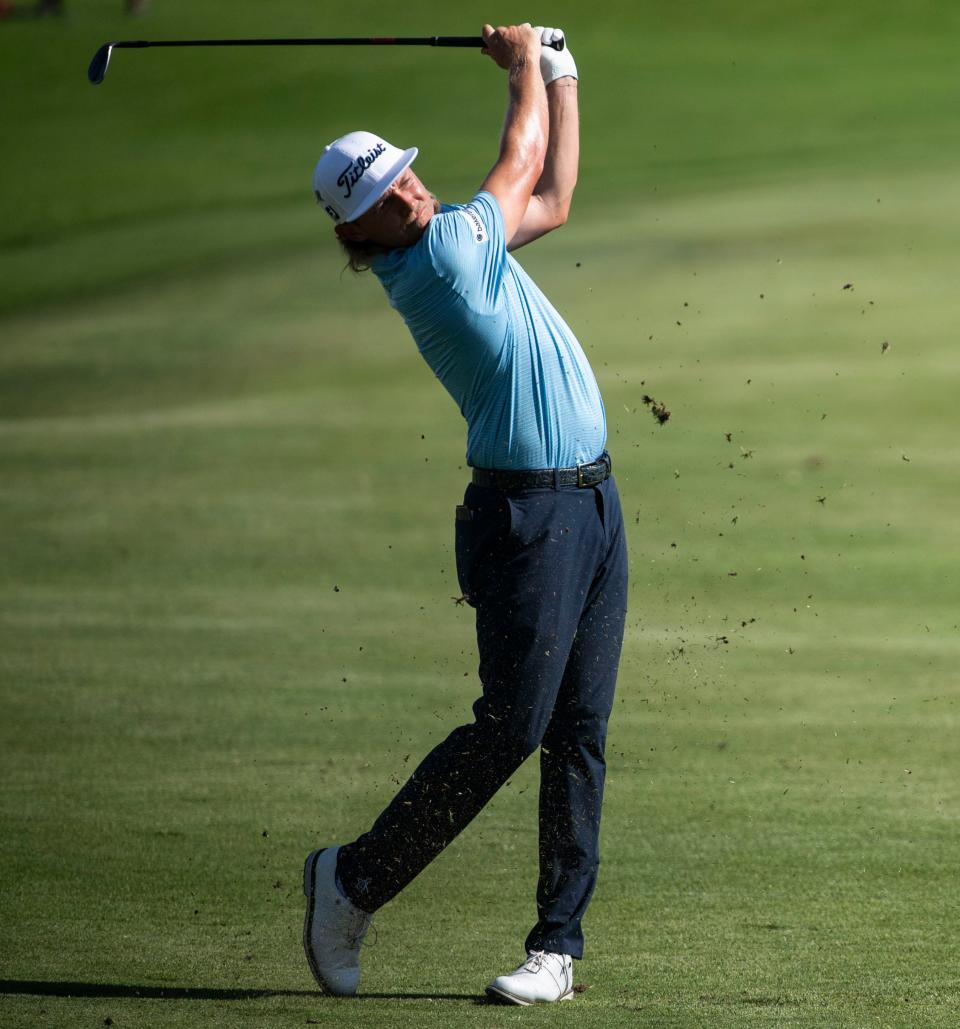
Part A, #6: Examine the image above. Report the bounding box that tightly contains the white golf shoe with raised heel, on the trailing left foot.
[304,847,372,997]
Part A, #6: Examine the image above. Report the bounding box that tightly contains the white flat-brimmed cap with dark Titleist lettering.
[314,132,419,221]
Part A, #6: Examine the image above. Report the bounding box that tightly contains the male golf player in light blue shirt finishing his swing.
[304,25,627,1004]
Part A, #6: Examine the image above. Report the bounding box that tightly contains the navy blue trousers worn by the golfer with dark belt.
[337,477,627,958]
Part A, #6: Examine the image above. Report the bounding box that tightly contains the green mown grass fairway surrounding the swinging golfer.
[0,0,960,1029]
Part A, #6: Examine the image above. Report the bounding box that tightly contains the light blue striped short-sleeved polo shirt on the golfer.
[371,192,606,469]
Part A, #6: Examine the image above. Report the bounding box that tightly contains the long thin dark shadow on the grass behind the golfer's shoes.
[0,979,479,1003]
